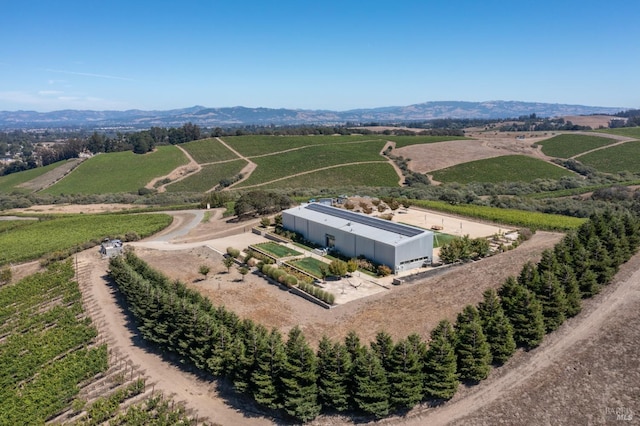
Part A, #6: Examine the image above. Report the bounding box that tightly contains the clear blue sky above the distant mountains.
[0,0,640,111]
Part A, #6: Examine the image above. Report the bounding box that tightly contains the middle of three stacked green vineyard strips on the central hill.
[238,141,386,188]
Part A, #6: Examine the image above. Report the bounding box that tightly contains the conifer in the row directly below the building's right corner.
[424,320,458,399]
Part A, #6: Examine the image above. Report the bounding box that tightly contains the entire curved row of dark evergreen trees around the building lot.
[110,213,640,422]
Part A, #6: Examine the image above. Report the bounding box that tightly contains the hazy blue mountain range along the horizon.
[0,101,625,129]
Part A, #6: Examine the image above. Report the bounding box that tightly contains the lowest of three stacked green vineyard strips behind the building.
[261,162,399,189]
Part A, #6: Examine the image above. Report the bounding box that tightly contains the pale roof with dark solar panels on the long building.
[285,203,433,246]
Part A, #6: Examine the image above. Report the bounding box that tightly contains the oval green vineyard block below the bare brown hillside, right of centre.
[433,155,573,184]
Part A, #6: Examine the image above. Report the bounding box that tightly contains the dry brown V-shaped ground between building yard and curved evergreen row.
[136,232,560,342]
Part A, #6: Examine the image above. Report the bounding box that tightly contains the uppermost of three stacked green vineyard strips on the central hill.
[223,135,384,157]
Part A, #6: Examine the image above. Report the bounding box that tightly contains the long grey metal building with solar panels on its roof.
[282,203,433,273]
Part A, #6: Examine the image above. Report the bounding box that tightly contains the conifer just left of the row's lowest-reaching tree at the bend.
[251,329,286,409]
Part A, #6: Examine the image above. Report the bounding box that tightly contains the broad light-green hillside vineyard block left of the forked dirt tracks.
[43,146,188,194]
